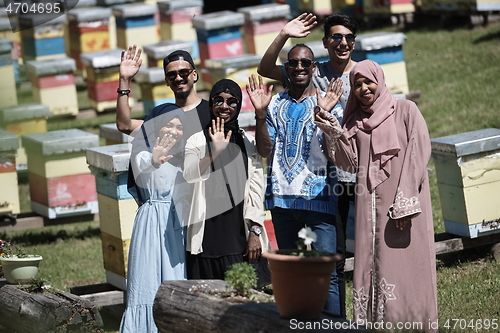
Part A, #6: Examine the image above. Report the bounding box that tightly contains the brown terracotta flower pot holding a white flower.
[262,250,342,319]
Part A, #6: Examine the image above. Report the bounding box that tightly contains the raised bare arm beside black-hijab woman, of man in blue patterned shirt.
[246,74,273,157]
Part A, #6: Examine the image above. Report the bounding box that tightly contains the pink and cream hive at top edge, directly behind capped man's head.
[158,0,203,63]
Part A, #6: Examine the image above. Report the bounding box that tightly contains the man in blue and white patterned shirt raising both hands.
[247,44,343,316]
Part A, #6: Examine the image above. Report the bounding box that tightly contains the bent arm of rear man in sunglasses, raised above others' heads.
[257,13,317,82]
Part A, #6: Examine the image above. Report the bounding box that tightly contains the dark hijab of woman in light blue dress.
[127,103,186,205]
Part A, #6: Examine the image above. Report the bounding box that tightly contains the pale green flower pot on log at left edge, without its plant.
[0,255,43,284]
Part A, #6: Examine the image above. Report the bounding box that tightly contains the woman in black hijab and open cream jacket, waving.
[183,79,269,285]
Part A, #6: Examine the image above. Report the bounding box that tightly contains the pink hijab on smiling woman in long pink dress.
[342,60,401,191]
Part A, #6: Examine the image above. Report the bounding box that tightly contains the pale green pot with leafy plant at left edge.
[0,240,43,284]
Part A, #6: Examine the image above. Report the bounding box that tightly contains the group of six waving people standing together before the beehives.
[116,13,437,333]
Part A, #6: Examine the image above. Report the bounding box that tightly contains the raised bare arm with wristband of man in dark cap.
[116,45,143,134]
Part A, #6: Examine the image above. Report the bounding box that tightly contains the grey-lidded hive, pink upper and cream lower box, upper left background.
[26,57,78,115]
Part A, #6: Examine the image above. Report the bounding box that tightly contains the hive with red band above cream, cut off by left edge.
[0,129,20,215]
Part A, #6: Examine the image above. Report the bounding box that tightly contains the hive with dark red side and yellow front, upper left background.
[68,7,111,73]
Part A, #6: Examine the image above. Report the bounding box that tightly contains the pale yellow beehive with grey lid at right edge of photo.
[431,128,500,238]
